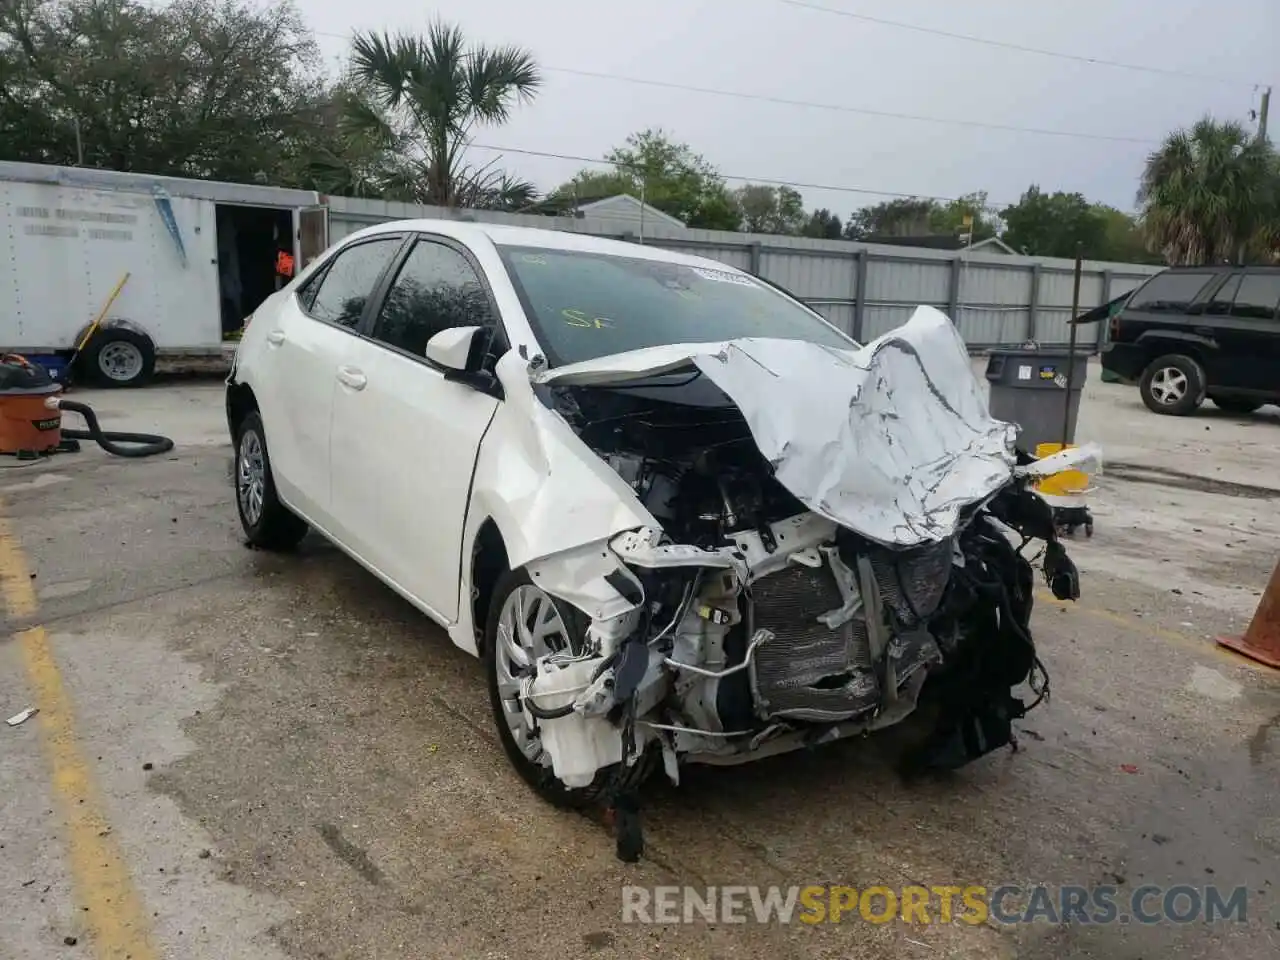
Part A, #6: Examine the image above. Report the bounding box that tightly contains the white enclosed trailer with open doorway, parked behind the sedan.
[0,163,329,387]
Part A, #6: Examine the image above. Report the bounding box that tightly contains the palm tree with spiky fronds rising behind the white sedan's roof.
[346,22,543,206]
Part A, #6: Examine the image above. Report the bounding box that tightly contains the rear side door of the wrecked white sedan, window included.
[252,233,404,529]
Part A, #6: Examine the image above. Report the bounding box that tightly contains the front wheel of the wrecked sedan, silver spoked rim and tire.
[484,570,652,808]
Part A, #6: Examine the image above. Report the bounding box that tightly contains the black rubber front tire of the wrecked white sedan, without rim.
[484,568,654,809]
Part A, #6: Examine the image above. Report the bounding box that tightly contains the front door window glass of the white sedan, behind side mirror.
[374,239,495,357]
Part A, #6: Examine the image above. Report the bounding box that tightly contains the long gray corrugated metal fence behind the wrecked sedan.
[328,197,1161,348]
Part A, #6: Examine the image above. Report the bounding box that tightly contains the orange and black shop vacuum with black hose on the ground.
[0,353,173,461]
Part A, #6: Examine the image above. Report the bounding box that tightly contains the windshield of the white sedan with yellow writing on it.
[498,244,856,366]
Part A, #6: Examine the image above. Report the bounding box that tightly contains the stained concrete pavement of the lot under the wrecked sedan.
[0,371,1280,960]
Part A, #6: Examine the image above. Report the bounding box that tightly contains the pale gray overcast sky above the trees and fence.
[296,0,1280,218]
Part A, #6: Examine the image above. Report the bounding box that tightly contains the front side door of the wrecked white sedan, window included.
[330,237,498,621]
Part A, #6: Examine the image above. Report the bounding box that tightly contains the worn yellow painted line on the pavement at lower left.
[0,516,159,960]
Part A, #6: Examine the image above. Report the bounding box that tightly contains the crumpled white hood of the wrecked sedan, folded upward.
[531,307,1016,547]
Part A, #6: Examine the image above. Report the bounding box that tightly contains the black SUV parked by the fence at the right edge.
[1102,266,1280,416]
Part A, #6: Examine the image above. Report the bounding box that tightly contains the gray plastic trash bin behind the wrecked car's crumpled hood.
[987,347,1089,454]
